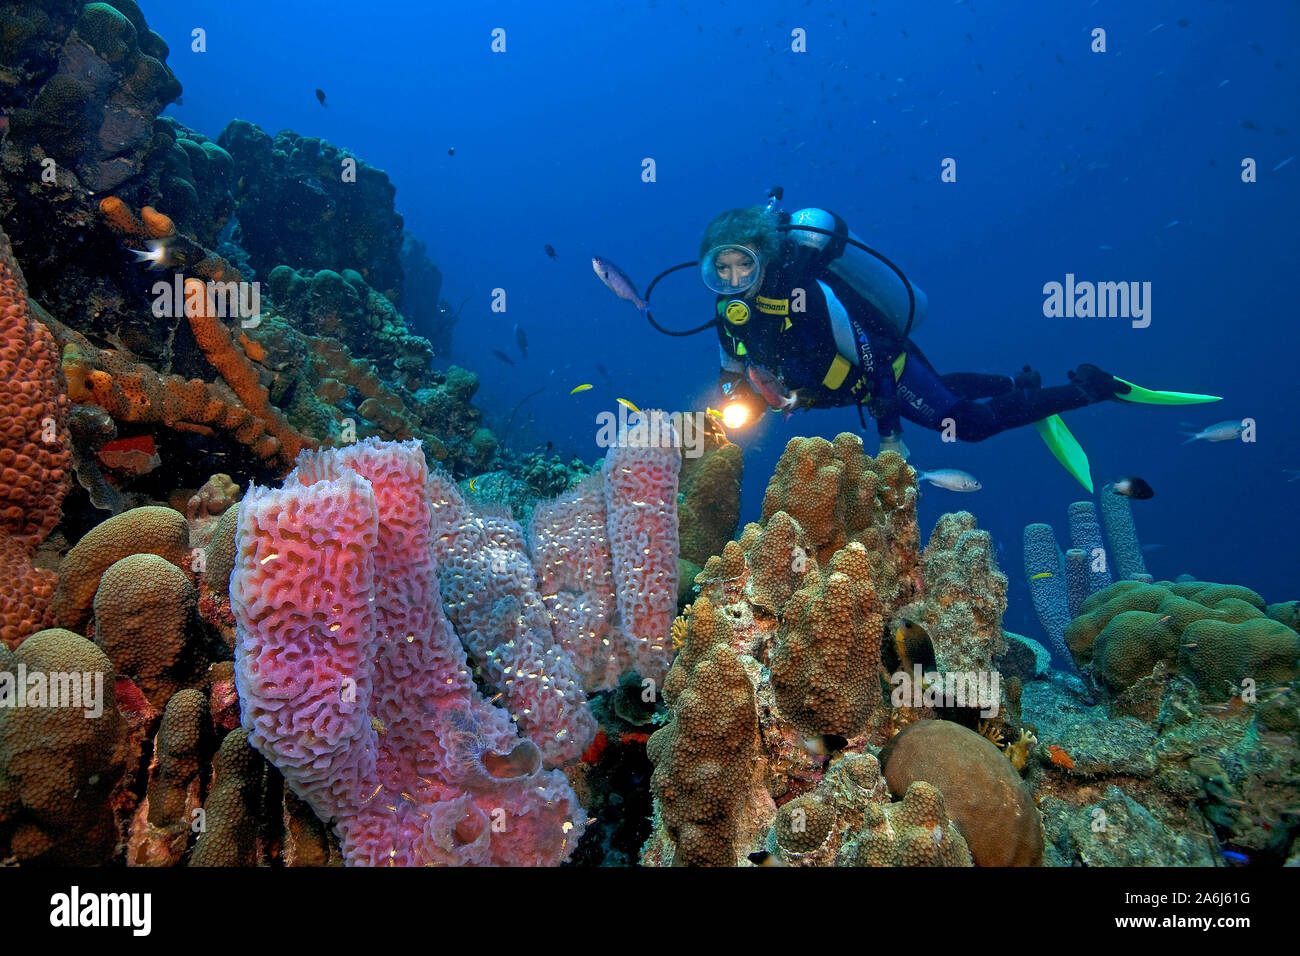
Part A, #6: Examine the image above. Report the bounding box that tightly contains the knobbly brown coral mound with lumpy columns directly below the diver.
[642,433,1024,866]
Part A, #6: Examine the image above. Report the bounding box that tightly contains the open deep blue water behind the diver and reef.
[142,0,1300,624]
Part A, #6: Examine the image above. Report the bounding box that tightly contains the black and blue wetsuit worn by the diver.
[716,225,1114,441]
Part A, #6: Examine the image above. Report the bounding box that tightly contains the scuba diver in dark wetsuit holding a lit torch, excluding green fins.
[699,200,1132,458]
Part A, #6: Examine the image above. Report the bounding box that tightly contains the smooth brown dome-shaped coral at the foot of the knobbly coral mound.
[880,721,1043,866]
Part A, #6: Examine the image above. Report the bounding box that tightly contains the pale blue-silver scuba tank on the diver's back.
[783,208,928,338]
